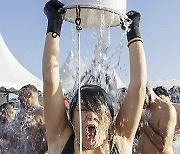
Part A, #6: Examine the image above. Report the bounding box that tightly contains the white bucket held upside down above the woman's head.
[61,0,126,28]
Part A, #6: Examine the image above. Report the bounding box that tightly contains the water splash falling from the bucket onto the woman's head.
[62,13,130,102]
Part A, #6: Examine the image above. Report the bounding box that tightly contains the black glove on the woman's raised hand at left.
[44,0,65,37]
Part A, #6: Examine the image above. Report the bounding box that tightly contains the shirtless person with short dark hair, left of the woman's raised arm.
[16,84,47,154]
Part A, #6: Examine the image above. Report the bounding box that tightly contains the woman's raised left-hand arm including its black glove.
[43,0,68,144]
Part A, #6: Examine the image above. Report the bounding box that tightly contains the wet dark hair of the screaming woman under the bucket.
[67,85,114,121]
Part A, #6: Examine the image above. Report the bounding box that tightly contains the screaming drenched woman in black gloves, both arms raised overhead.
[43,0,147,154]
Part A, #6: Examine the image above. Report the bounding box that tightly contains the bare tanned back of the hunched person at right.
[137,100,176,154]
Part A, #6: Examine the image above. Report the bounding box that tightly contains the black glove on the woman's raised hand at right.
[126,11,141,42]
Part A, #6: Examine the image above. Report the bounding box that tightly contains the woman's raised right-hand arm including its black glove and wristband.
[116,11,147,144]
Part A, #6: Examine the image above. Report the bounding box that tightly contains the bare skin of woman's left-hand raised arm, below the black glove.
[43,33,66,143]
